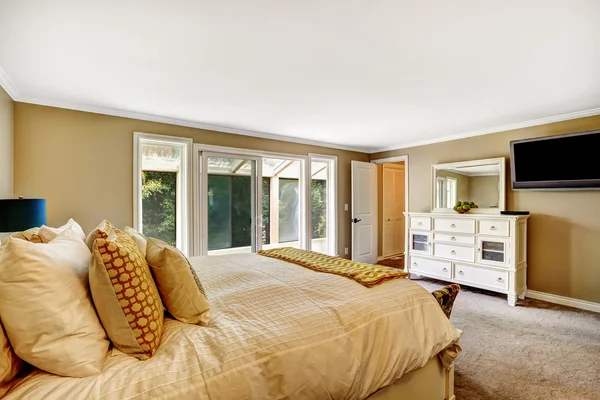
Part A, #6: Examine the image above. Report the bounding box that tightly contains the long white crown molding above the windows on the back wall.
[11,96,369,154]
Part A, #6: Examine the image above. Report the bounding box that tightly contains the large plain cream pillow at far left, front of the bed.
[0,227,110,377]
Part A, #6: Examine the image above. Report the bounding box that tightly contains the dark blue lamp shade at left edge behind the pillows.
[0,199,46,232]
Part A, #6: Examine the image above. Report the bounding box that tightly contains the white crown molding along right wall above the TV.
[370,107,600,154]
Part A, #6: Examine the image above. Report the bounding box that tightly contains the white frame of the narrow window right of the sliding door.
[306,153,339,256]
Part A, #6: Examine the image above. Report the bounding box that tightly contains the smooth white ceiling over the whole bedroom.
[0,0,600,152]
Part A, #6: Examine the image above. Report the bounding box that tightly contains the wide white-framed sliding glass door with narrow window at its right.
[194,145,337,255]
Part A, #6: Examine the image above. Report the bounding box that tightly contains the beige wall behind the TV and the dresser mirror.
[371,116,600,303]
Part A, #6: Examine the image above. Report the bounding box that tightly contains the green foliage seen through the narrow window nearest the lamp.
[142,171,177,246]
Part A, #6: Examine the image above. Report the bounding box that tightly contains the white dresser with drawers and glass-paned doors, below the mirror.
[405,212,528,306]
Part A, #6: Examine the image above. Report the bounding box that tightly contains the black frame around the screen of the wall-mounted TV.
[510,129,600,190]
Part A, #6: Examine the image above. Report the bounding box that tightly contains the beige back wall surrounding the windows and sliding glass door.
[14,103,369,256]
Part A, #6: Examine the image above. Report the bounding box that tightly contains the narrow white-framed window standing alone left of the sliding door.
[133,132,192,254]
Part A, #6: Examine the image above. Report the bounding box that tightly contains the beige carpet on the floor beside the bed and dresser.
[415,279,600,400]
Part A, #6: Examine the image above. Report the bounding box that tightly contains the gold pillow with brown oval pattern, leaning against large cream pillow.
[90,229,164,360]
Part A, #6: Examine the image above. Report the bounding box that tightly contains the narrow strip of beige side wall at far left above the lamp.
[0,86,14,199]
